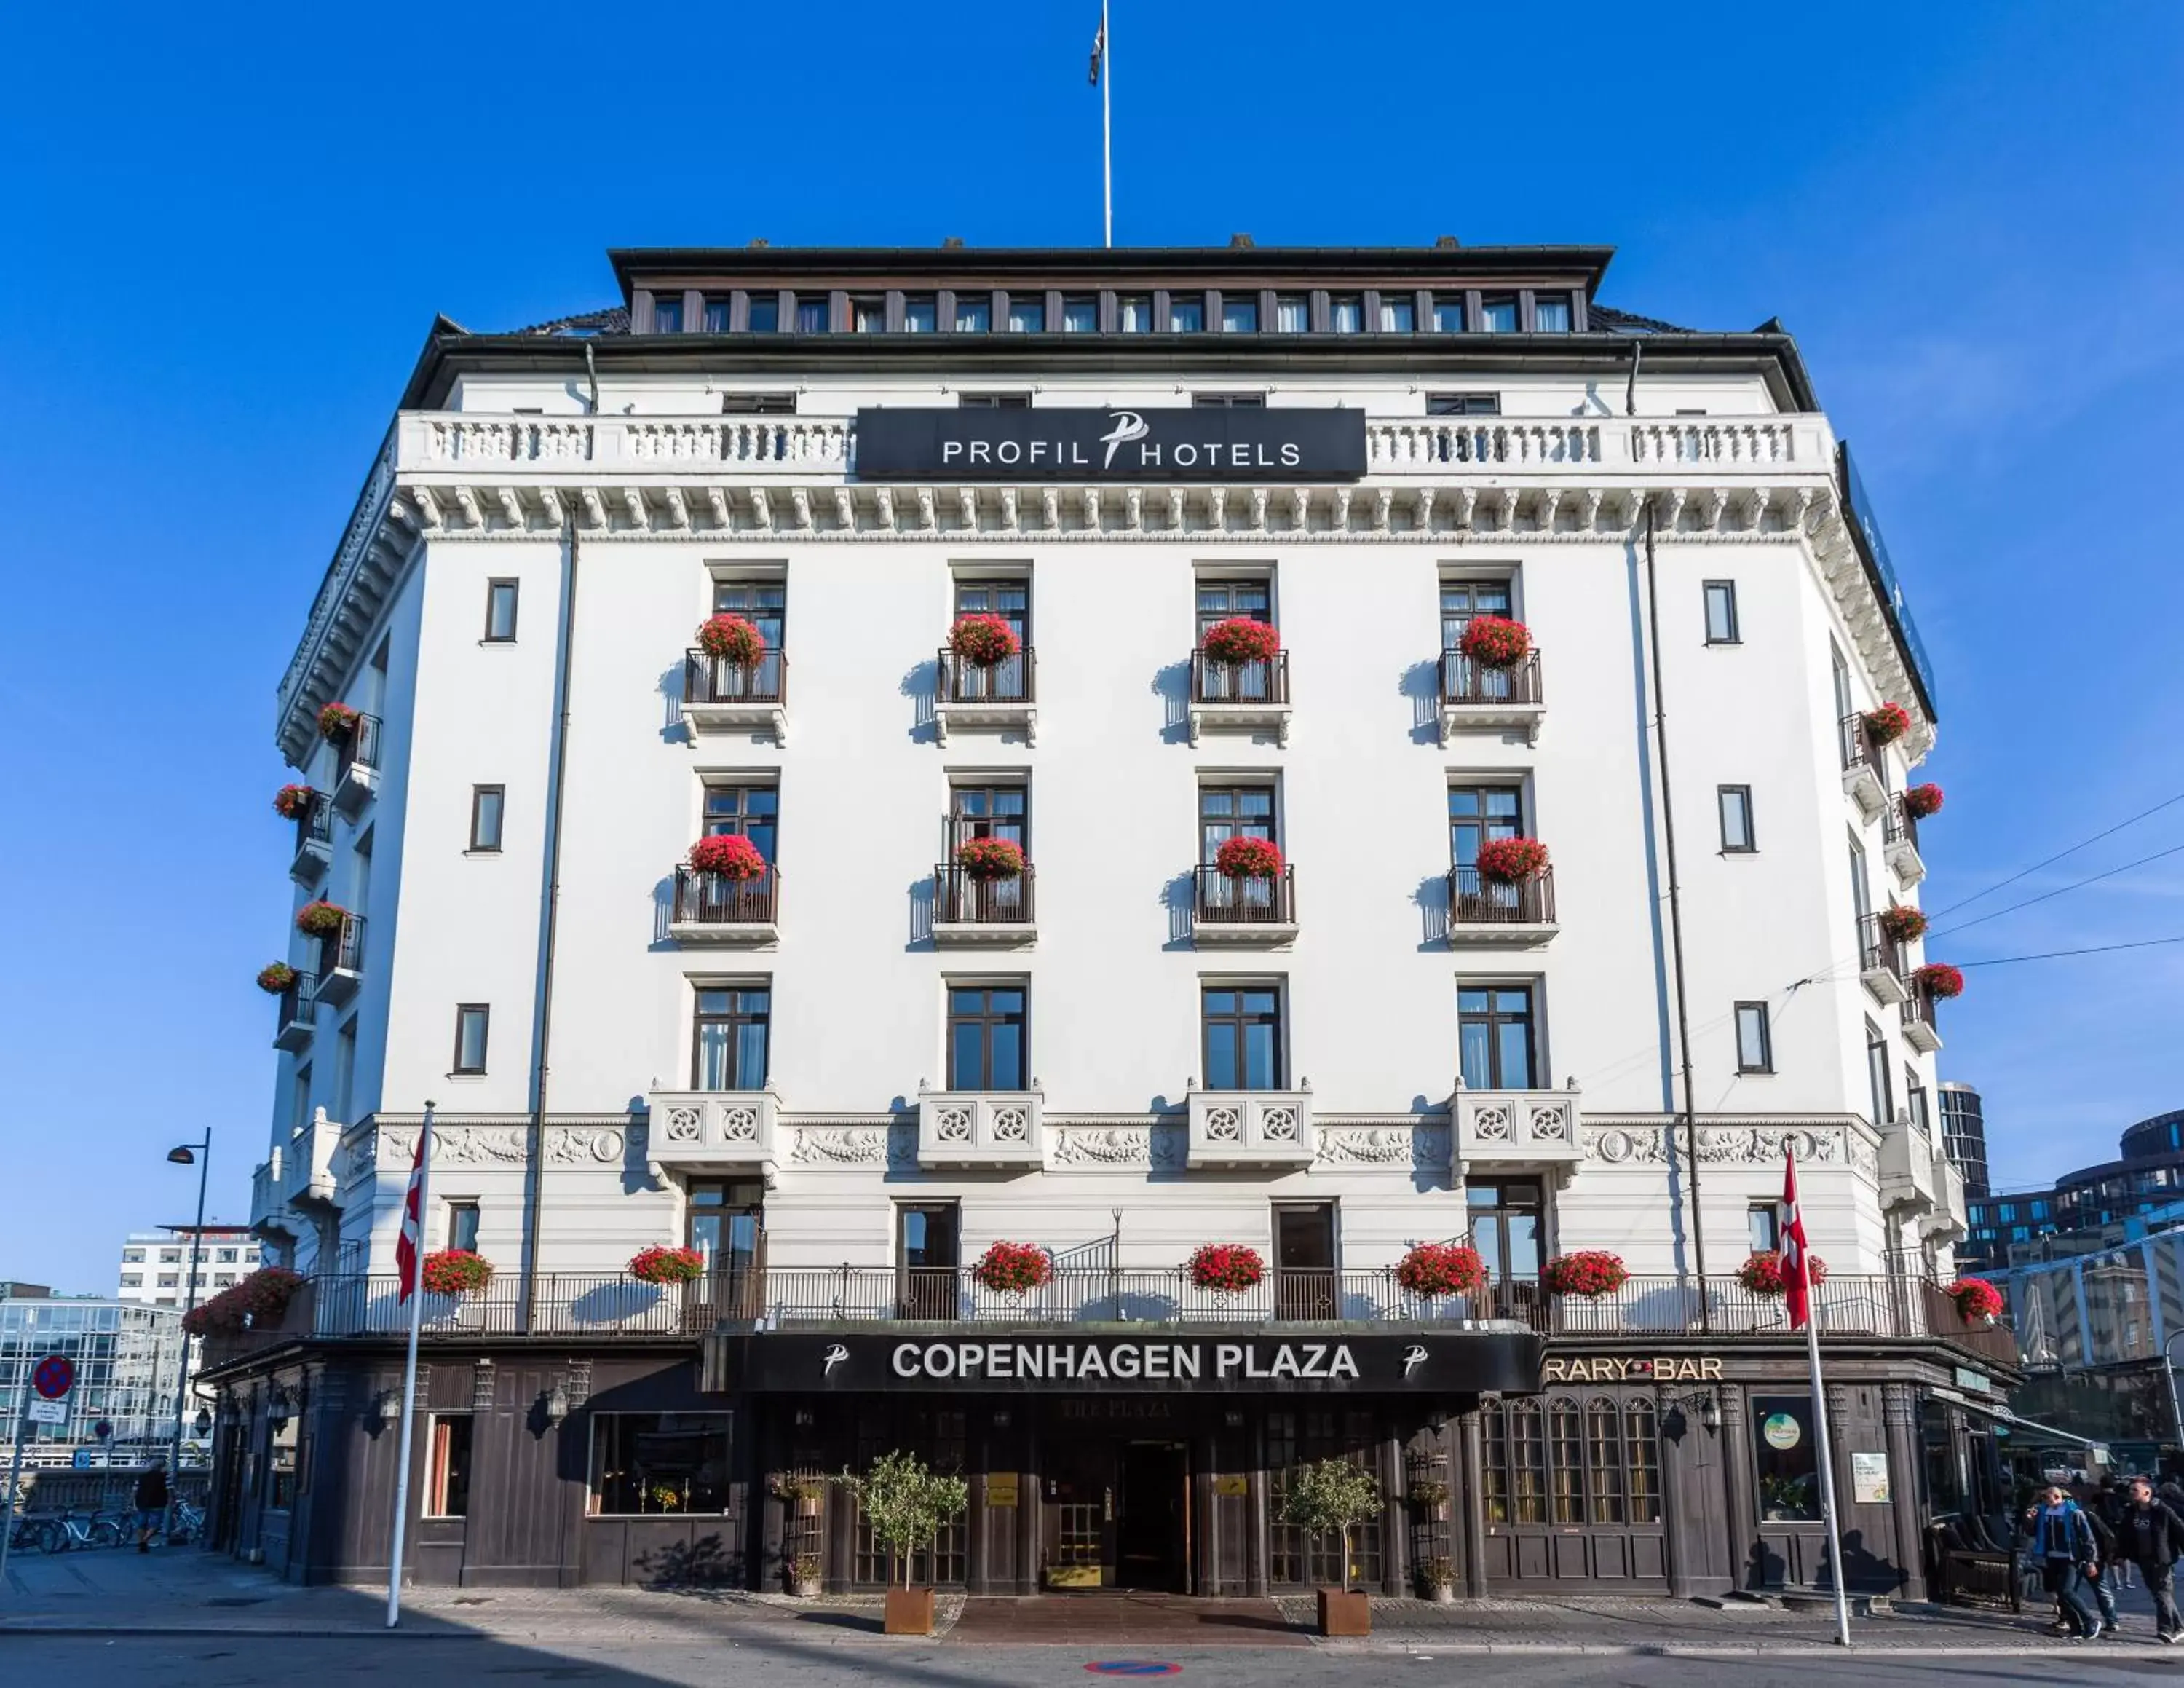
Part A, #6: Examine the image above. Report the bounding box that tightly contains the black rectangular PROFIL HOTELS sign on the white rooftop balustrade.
[856,406,1365,483]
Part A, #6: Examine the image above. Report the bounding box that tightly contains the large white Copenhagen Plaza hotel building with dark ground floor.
[212,242,2011,1594]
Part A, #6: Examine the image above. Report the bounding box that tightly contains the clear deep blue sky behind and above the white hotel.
[0,0,2184,1288]
